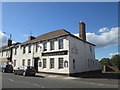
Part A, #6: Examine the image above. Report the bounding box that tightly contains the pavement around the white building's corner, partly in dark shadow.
[36,72,120,85]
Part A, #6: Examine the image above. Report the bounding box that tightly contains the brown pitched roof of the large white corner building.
[20,29,95,46]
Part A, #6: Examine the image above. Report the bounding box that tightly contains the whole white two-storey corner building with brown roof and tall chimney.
[0,22,101,75]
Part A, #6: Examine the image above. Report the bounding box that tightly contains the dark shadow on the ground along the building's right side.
[70,71,120,79]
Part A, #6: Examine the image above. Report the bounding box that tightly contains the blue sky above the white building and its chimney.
[2,2,118,59]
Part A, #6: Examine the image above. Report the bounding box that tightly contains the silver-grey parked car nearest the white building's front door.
[14,66,36,76]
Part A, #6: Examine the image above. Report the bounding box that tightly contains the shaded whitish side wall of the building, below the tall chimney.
[69,36,101,73]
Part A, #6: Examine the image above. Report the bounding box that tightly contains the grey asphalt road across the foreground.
[2,73,118,88]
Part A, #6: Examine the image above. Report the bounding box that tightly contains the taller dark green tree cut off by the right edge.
[111,54,120,70]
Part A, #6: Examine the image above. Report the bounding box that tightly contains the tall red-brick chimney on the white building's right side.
[79,21,86,41]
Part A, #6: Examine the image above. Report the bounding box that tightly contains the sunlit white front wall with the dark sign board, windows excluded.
[12,36,69,74]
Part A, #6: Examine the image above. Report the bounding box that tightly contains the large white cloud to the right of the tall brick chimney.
[74,27,120,48]
